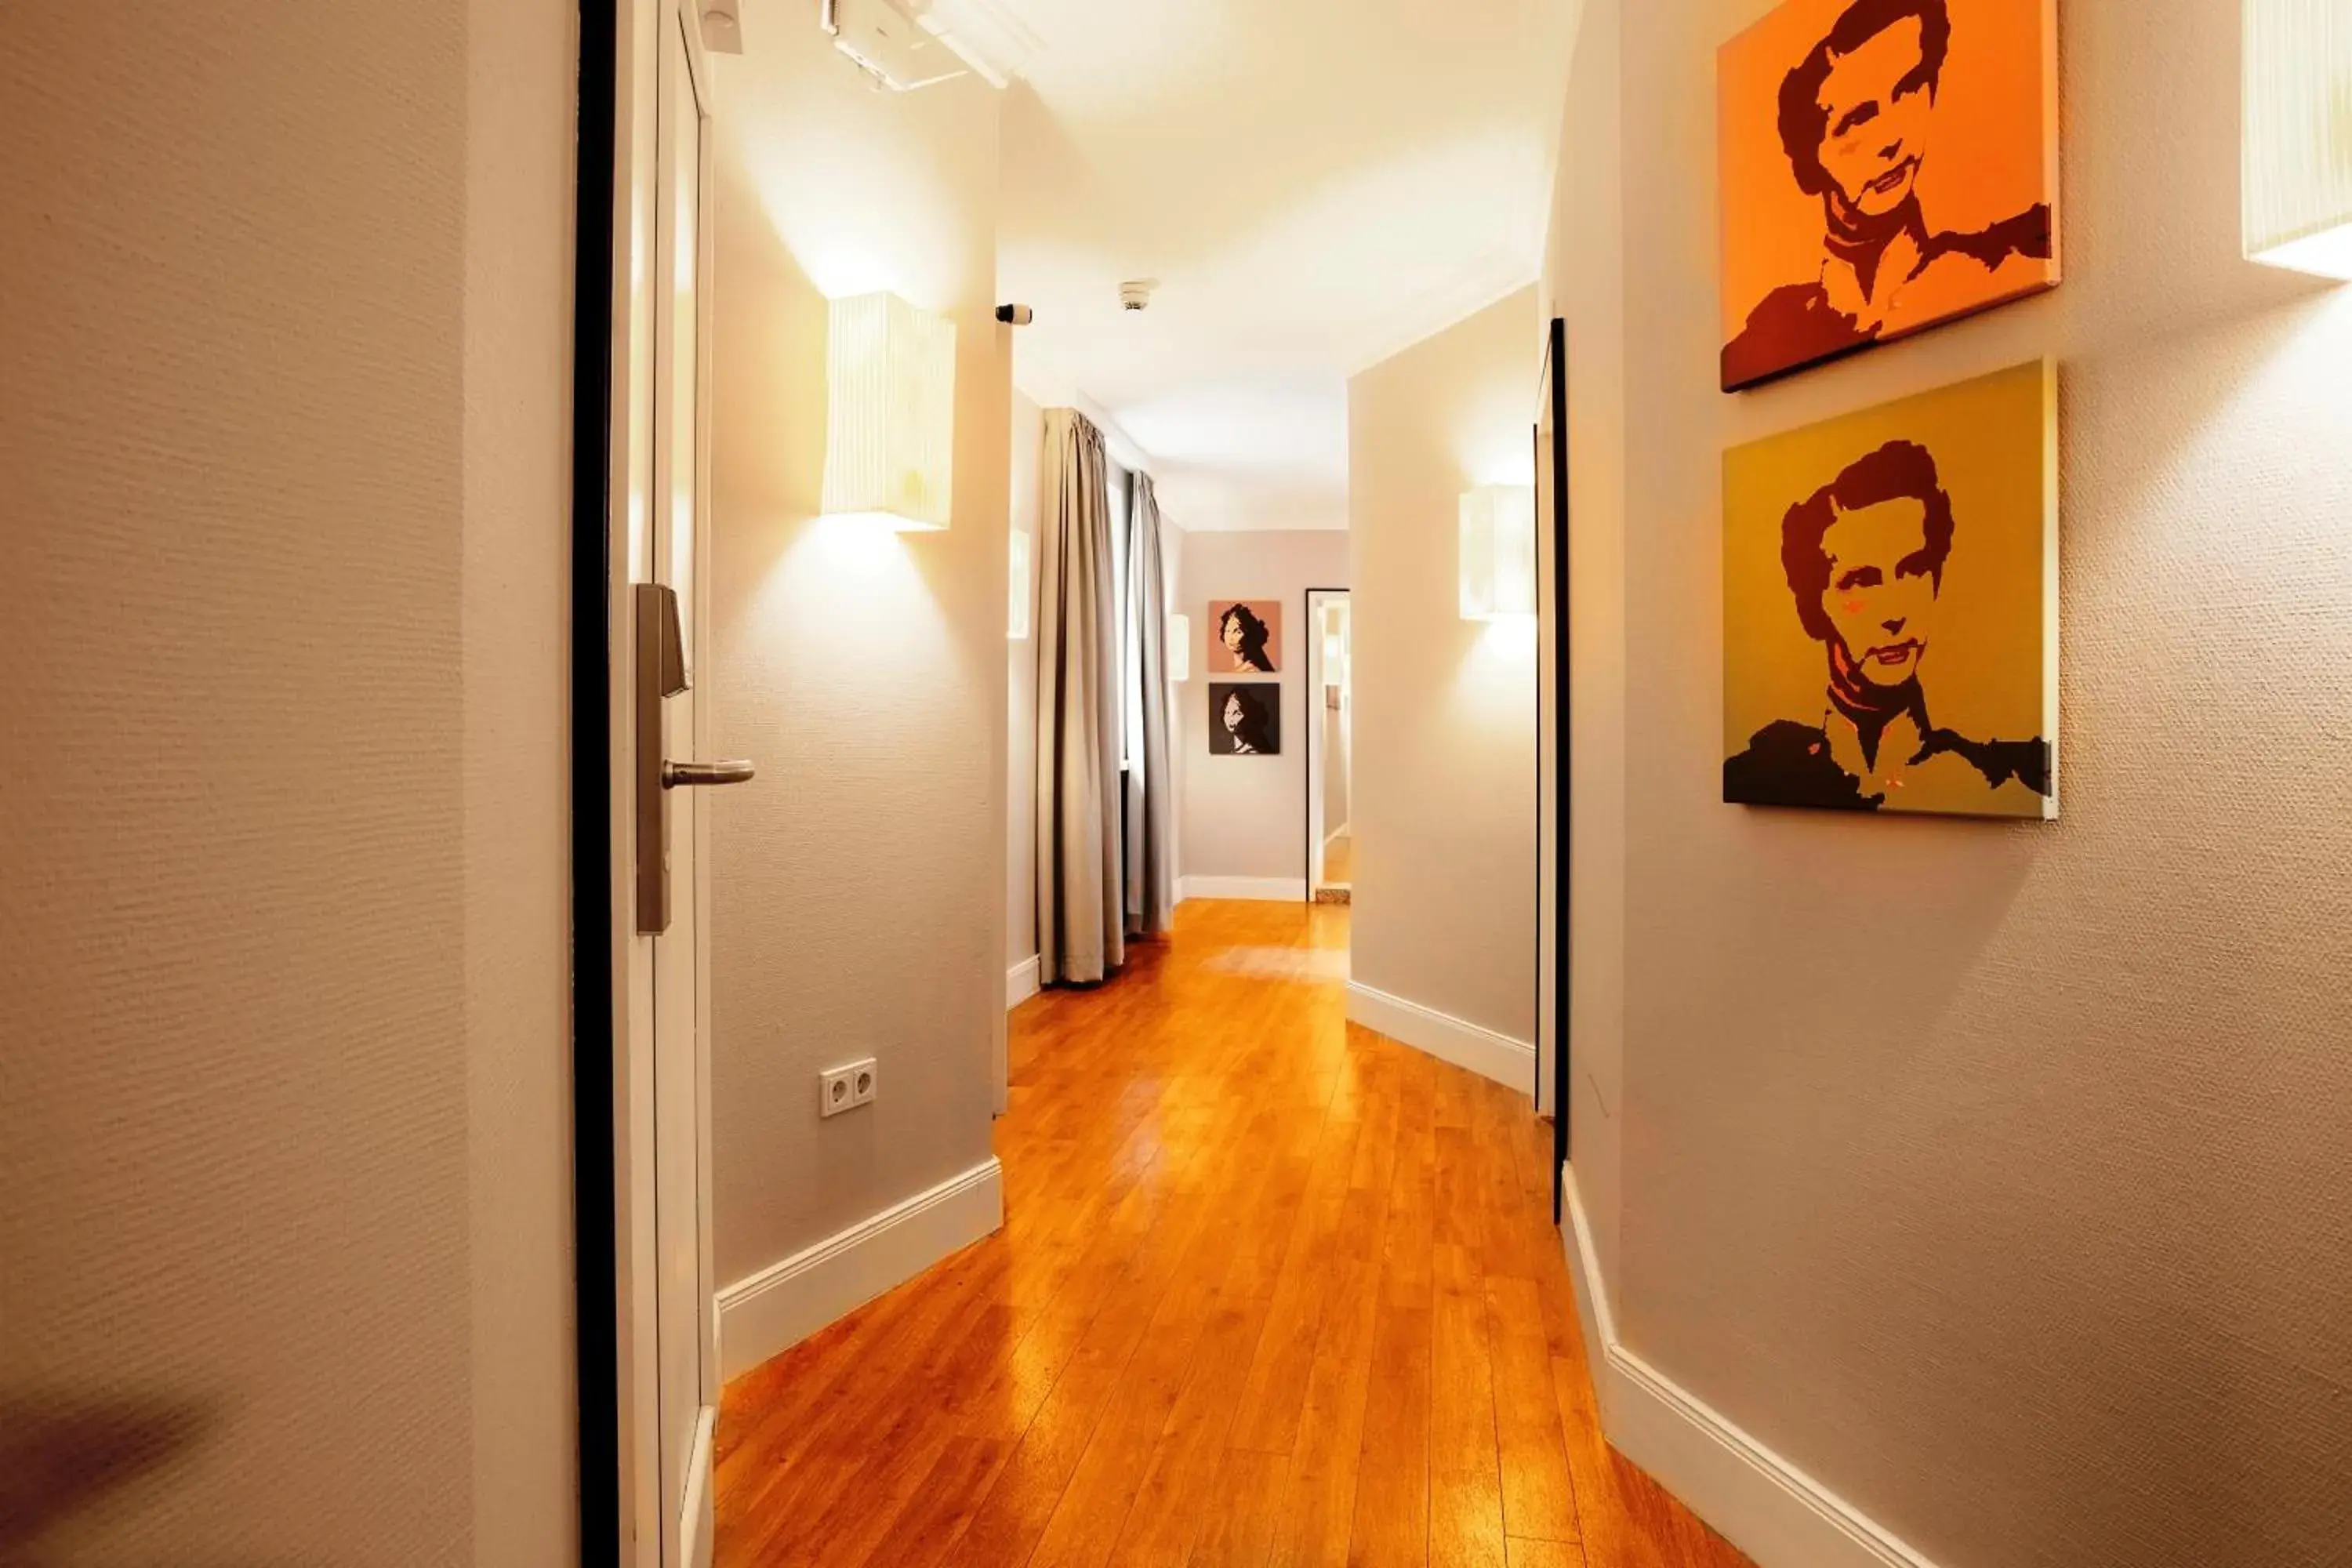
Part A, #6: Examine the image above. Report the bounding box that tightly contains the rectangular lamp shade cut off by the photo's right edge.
[2244,0,2352,280]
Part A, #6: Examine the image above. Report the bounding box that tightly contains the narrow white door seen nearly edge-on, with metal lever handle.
[649,5,720,1568]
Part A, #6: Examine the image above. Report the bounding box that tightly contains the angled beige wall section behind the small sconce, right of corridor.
[1348,289,1543,1048]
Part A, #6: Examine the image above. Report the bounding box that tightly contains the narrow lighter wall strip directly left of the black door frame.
[463,0,579,1568]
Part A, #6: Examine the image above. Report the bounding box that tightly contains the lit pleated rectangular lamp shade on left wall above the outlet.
[823,294,955,532]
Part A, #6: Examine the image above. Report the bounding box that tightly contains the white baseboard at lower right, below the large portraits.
[1564,1166,1936,1568]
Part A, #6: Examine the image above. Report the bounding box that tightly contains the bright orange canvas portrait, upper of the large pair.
[1717,0,2058,393]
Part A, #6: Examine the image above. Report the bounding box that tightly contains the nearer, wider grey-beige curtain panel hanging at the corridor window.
[1037,409,1127,985]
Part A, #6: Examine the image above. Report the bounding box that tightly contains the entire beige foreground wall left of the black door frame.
[0,0,579,1566]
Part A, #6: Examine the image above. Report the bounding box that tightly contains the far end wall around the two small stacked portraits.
[1169,529,1348,898]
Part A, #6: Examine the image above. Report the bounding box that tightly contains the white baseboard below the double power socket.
[720,1156,1004,1377]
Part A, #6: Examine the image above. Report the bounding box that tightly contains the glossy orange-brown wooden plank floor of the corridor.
[717,902,1745,1568]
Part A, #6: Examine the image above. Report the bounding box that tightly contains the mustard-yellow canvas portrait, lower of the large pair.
[1724,362,2058,818]
